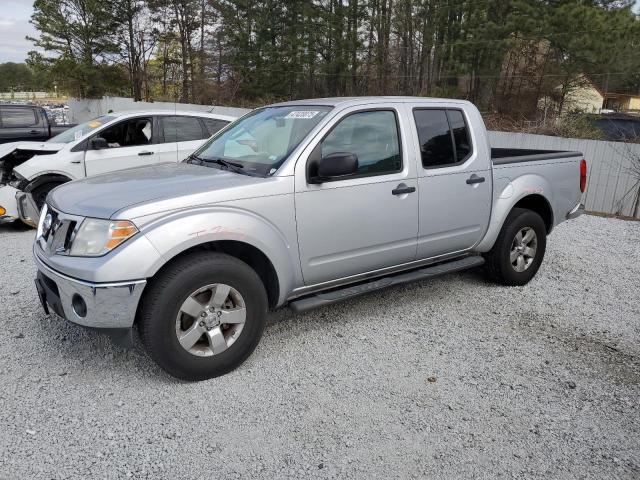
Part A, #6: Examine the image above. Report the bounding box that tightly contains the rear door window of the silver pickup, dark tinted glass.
[413,109,472,168]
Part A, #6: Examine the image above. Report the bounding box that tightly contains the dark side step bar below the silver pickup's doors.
[289,256,484,312]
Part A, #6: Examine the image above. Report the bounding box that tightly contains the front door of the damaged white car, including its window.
[85,116,158,176]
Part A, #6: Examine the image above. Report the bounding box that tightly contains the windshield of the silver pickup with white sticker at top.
[188,105,332,176]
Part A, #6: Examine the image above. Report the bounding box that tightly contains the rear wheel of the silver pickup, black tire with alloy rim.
[484,208,547,286]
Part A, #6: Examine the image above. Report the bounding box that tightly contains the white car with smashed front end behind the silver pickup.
[0,111,236,226]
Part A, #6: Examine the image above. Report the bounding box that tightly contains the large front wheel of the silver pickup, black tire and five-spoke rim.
[138,252,268,381]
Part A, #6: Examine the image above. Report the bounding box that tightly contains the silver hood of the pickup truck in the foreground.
[48,163,286,219]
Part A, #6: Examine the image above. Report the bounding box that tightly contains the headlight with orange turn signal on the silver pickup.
[69,218,138,257]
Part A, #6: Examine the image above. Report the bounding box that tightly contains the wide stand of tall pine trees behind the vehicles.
[22,0,640,112]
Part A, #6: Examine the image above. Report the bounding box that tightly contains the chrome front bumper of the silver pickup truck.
[34,251,147,329]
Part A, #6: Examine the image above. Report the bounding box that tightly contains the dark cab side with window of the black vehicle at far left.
[0,105,49,143]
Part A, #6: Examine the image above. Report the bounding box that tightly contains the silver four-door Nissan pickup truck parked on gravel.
[34,97,586,380]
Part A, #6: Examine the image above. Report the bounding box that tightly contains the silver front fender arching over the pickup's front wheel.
[139,206,297,304]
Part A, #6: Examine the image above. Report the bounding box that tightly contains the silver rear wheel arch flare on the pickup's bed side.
[475,173,553,252]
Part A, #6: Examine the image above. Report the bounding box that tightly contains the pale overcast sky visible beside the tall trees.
[0,0,640,63]
